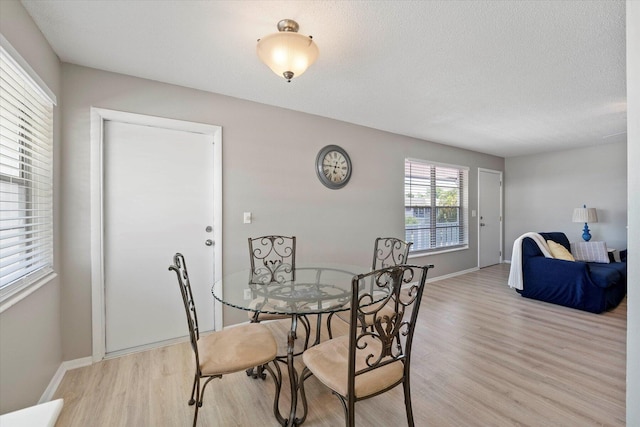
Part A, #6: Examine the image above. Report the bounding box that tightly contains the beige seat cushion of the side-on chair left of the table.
[198,323,278,375]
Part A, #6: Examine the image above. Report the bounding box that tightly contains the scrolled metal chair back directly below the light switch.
[249,235,296,284]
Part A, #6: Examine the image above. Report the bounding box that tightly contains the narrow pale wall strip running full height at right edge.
[627,0,640,426]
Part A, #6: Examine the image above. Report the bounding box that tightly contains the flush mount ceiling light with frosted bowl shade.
[256,19,319,82]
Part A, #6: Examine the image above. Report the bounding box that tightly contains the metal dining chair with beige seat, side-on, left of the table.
[169,253,282,427]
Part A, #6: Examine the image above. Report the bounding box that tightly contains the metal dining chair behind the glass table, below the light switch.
[247,235,311,379]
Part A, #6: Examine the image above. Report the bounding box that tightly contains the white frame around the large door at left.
[90,107,222,362]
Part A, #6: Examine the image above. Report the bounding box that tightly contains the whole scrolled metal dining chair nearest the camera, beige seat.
[300,265,433,427]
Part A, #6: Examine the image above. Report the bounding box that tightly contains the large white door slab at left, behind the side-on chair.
[103,121,214,353]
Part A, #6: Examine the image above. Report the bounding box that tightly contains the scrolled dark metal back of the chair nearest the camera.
[348,265,433,393]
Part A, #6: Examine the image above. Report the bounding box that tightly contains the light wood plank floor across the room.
[55,265,627,427]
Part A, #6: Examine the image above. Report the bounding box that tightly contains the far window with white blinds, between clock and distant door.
[404,159,469,252]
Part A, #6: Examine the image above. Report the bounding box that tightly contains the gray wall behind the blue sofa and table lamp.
[505,142,627,260]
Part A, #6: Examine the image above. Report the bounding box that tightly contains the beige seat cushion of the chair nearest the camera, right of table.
[302,335,404,398]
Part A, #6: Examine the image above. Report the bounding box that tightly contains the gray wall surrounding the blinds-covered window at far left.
[0,0,64,413]
